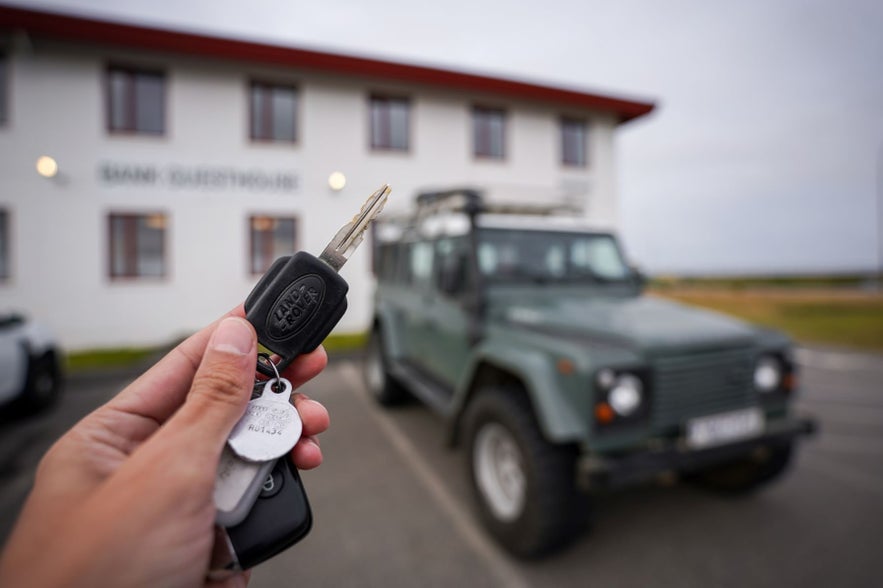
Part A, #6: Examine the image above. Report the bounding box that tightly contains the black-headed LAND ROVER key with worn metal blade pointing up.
[245,184,390,377]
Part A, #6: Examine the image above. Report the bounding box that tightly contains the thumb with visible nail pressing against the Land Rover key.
[159,317,257,455]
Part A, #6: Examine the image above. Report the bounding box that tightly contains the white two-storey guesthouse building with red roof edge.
[0,6,652,349]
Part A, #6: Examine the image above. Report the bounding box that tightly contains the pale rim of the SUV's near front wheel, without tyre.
[472,423,527,522]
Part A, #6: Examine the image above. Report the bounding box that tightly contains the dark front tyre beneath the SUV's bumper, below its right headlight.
[694,443,793,495]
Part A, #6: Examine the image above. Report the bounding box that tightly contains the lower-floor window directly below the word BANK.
[109,212,168,278]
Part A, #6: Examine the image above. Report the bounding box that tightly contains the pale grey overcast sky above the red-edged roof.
[12,0,883,273]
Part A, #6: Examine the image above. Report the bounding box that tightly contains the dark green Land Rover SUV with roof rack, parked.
[364,190,813,557]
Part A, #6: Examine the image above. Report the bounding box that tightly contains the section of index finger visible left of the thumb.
[108,304,245,425]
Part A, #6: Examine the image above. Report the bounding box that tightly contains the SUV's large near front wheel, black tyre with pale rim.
[464,387,588,558]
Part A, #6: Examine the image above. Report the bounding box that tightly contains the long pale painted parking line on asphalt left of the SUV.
[340,363,529,588]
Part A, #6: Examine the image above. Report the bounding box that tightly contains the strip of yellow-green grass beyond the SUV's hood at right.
[649,281,883,351]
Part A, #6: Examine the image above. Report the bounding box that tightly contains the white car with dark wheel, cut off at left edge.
[0,314,63,413]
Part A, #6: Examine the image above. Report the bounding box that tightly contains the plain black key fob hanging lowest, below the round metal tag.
[209,454,313,579]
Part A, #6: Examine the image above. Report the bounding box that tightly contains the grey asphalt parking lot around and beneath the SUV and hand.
[0,350,883,588]
